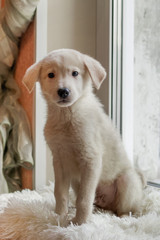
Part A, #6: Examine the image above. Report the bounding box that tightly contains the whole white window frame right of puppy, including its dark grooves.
[109,0,134,163]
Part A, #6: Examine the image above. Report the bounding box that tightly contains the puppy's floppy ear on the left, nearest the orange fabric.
[22,62,41,93]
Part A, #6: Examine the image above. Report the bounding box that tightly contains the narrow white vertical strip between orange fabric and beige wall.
[33,0,47,189]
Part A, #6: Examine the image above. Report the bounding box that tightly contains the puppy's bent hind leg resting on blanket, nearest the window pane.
[116,169,143,216]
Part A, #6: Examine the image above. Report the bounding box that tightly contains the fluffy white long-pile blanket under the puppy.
[0,183,160,240]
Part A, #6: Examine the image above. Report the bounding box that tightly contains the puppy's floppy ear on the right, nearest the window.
[84,55,107,89]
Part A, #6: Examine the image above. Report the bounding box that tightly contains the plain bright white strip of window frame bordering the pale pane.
[122,0,134,163]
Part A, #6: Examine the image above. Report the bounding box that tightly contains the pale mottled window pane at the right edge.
[134,0,160,179]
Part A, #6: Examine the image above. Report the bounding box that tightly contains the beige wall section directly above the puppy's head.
[48,0,96,57]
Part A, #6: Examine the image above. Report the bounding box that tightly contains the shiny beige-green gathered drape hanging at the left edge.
[0,0,39,193]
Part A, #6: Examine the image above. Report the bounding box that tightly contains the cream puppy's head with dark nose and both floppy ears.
[22,49,106,107]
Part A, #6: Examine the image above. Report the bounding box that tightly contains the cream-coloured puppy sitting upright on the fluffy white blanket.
[23,49,143,224]
